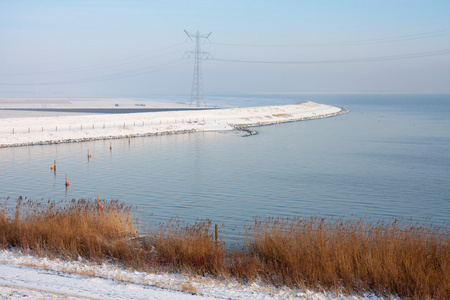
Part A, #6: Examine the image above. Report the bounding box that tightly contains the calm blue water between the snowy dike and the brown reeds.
[0,95,450,239]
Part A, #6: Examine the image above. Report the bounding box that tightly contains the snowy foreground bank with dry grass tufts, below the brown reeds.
[0,250,381,300]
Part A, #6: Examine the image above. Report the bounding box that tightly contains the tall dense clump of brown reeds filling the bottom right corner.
[246,217,450,299]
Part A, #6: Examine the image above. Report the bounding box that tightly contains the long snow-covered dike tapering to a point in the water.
[0,101,348,147]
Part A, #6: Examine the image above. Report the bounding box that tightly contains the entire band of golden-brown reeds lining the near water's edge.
[0,198,450,299]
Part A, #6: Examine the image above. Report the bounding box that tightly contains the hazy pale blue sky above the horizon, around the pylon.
[0,0,450,96]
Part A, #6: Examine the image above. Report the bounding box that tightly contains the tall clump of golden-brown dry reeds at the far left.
[0,198,136,259]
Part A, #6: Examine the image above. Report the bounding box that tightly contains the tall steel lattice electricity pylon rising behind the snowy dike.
[184,30,212,106]
